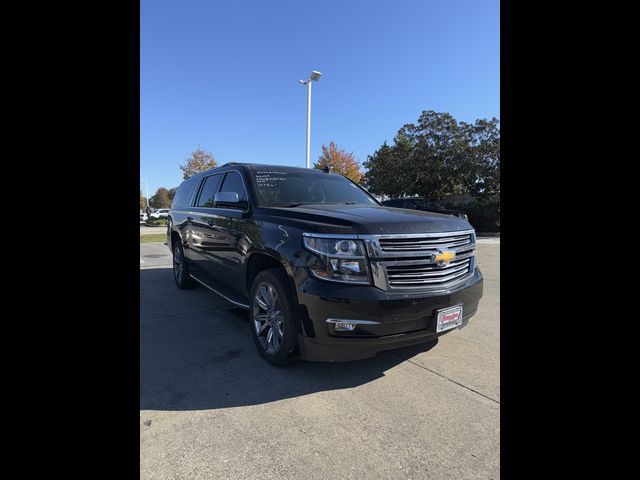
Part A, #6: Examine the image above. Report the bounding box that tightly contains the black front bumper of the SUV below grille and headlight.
[297,268,483,362]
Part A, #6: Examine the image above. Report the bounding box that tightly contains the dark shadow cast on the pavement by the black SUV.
[140,268,437,410]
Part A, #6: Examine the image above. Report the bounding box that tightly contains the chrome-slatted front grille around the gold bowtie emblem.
[377,230,476,290]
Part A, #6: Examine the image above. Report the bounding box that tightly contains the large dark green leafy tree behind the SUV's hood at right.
[364,110,500,200]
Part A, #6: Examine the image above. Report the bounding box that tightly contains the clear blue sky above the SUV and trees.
[140,0,500,194]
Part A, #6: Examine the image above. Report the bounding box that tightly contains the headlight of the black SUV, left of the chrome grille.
[302,236,371,285]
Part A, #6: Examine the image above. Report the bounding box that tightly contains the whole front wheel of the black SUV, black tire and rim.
[249,268,298,366]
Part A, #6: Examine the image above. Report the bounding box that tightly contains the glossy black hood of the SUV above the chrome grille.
[263,204,473,235]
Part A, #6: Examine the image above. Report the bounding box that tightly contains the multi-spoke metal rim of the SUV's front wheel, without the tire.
[252,282,284,354]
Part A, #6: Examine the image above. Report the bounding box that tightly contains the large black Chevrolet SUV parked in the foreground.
[167,163,483,365]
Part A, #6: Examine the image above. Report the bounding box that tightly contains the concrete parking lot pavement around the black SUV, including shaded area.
[140,239,500,480]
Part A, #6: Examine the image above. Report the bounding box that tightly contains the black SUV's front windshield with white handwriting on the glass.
[250,167,379,207]
